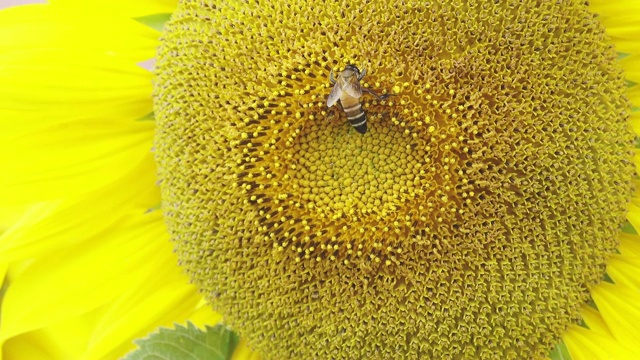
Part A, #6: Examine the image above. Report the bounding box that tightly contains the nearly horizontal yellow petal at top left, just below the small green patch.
[0,4,159,61]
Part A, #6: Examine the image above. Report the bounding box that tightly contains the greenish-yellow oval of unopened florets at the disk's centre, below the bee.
[292,121,420,220]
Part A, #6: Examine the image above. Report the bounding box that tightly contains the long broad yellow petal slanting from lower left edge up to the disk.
[0,212,169,340]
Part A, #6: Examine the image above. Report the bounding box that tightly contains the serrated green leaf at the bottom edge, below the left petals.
[124,323,239,360]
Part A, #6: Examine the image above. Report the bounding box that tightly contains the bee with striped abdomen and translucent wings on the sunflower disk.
[327,64,389,135]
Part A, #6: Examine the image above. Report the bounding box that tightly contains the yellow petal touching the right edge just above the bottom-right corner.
[591,282,640,352]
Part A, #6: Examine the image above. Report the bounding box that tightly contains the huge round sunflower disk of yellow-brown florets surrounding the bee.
[154,0,634,359]
